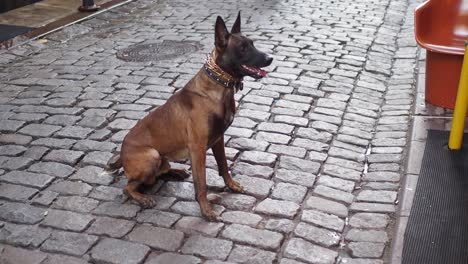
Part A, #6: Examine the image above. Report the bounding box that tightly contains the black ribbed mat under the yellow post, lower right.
[402,130,468,264]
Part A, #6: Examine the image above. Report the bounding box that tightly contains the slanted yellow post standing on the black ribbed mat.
[449,38,468,150]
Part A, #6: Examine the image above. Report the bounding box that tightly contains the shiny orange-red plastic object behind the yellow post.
[415,0,468,109]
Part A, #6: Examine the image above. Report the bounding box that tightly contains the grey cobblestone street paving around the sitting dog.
[0,0,419,264]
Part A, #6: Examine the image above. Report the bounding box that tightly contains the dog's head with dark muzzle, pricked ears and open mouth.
[215,12,273,79]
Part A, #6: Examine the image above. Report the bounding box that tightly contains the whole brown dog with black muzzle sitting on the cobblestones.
[108,12,273,220]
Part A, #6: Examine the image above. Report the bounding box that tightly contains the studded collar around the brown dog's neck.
[203,54,244,91]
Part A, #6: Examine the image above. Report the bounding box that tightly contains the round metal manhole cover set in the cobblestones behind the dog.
[117,40,201,62]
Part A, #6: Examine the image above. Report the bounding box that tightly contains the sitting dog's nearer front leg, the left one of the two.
[189,144,221,221]
